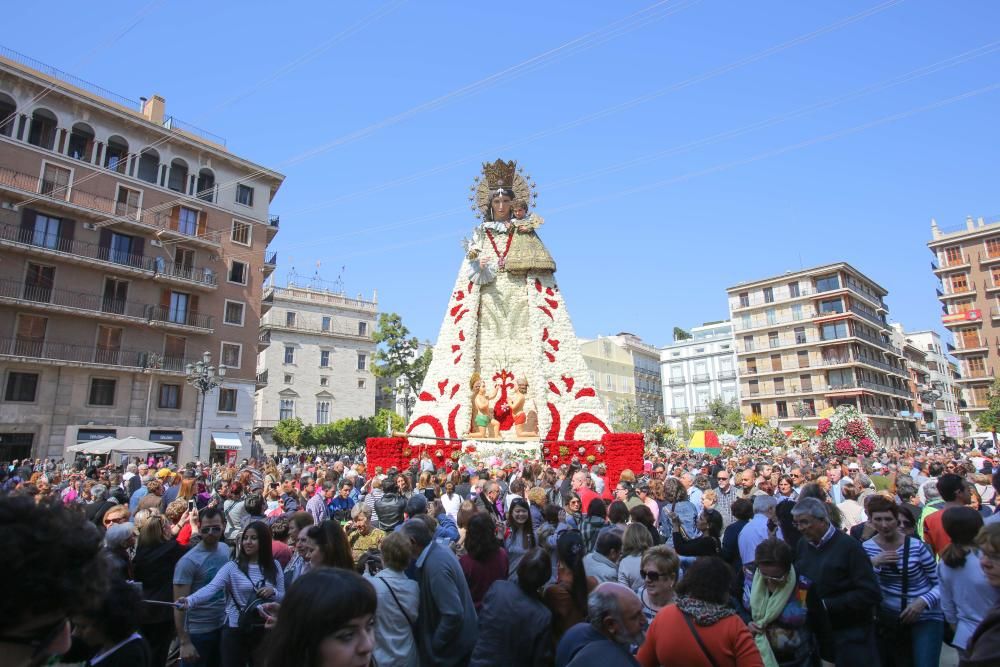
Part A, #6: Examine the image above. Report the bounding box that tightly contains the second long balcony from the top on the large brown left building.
[0,223,218,289]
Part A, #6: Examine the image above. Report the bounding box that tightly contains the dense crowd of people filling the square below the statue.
[0,449,1000,667]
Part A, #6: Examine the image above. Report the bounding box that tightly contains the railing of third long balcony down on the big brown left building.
[0,279,212,329]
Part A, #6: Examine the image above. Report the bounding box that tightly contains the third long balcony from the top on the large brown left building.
[0,279,213,334]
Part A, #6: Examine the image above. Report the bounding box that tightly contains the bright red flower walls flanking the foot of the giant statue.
[366,433,644,484]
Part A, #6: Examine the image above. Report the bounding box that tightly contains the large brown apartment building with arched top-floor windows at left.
[0,50,284,461]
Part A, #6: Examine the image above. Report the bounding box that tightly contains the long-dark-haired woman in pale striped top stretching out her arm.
[177,521,285,667]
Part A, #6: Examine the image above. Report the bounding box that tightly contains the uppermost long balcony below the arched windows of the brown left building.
[0,167,219,248]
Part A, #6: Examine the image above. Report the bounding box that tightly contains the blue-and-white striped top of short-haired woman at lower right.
[861,537,944,621]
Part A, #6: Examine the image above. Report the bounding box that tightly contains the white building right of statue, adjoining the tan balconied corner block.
[660,321,739,427]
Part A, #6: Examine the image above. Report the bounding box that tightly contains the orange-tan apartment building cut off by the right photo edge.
[927,217,1000,434]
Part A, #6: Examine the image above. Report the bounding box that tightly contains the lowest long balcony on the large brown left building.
[0,337,197,375]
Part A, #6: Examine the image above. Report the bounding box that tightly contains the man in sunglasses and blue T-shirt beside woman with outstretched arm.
[174,506,229,667]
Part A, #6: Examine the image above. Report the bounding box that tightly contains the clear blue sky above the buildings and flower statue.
[9,0,1000,345]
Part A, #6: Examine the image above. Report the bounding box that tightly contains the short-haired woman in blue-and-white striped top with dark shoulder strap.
[862,497,944,667]
